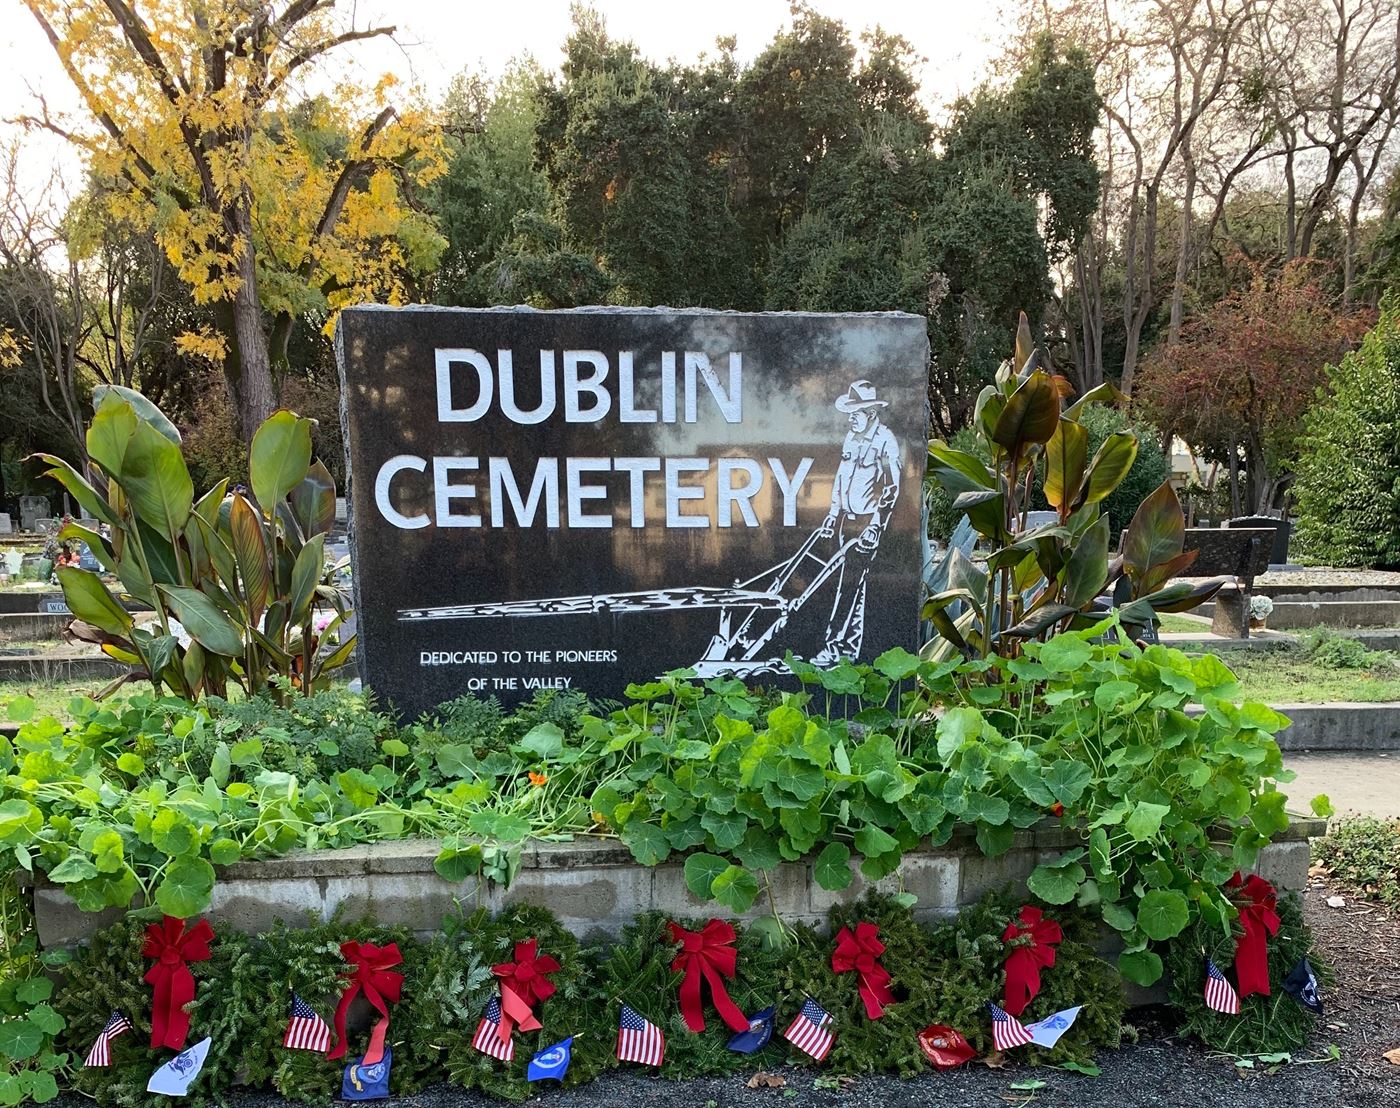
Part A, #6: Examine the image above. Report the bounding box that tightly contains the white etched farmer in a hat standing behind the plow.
[812,381,899,665]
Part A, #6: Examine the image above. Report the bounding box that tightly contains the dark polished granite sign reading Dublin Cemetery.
[336,305,928,713]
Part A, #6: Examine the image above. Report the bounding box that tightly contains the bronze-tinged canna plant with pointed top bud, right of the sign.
[924,312,1225,660]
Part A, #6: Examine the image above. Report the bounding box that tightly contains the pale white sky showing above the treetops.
[0,0,1008,190]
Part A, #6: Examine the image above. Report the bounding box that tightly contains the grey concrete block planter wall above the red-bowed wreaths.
[35,818,1326,947]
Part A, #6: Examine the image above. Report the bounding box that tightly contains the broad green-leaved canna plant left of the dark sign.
[35,385,356,699]
